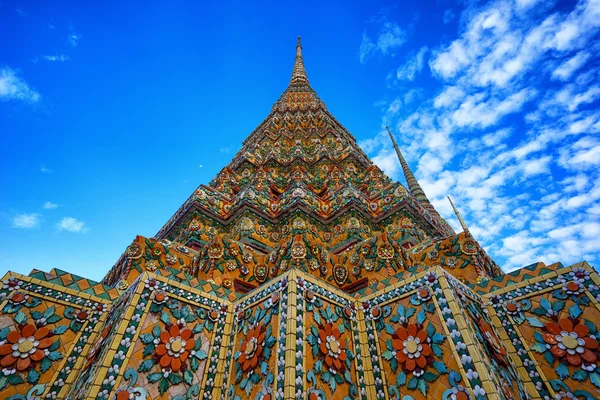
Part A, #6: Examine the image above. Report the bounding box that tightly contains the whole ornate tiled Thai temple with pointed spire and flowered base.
[0,40,600,400]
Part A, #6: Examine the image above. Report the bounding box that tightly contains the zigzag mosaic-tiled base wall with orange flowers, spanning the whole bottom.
[0,264,600,400]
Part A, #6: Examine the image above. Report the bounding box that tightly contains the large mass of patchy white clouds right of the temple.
[360,0,600,270]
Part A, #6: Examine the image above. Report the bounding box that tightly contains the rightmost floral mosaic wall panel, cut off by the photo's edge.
[489,268,600,399]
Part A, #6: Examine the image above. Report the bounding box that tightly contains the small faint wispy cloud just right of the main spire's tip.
[358,18,408,64]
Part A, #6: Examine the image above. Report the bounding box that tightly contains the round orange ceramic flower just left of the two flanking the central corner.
[156,325,196,372]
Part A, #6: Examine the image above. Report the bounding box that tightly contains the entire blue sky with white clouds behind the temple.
[0,0,600,280]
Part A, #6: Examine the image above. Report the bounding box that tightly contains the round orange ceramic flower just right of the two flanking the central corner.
[392,324,432,371]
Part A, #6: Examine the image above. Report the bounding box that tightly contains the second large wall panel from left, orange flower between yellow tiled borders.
[69,273,233,400]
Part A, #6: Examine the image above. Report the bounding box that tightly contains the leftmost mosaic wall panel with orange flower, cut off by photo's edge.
[0,272,111,400]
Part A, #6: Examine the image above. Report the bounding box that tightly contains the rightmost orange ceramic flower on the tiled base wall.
[544,318,598,365]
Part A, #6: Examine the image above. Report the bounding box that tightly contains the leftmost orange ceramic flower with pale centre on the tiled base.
[0,325,52,371]
